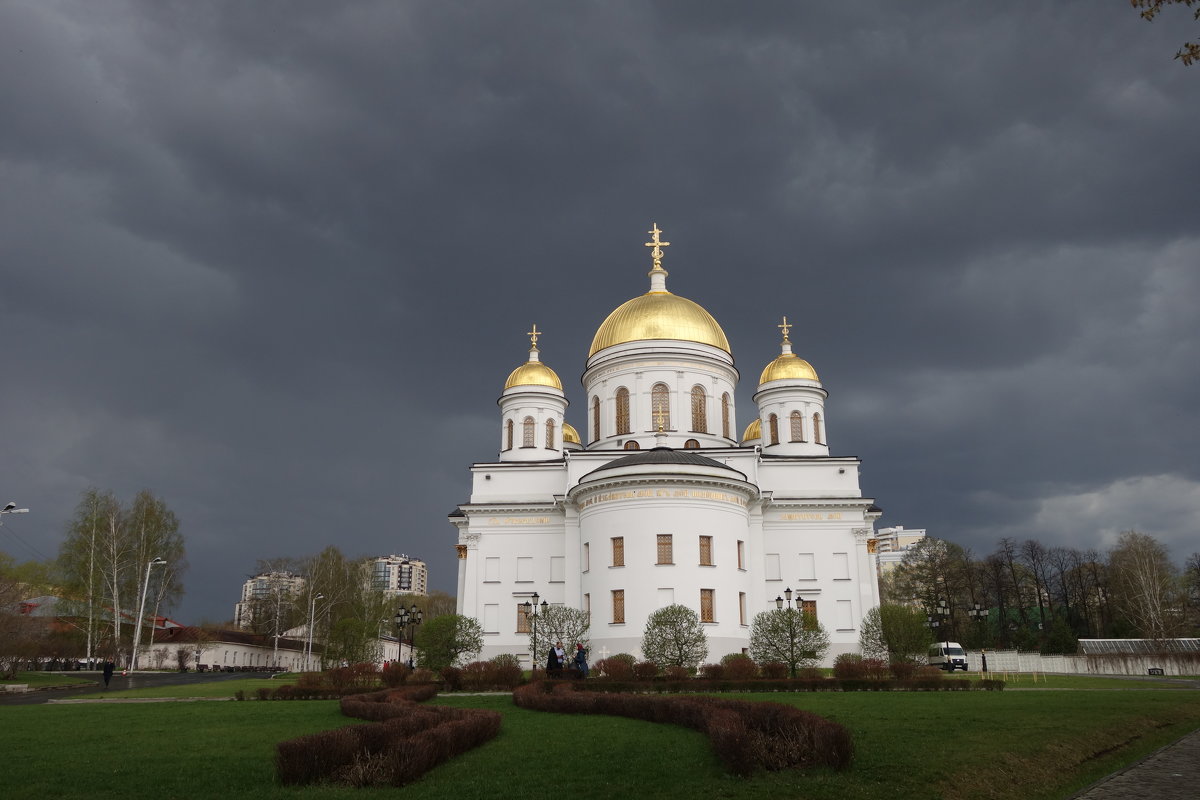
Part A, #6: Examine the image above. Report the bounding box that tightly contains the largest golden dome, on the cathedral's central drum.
[588,291,730,356]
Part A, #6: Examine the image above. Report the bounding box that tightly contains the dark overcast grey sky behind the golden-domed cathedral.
[0,0,1200,621]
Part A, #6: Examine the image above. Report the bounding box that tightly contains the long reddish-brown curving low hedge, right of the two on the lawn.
[512,681,854,776]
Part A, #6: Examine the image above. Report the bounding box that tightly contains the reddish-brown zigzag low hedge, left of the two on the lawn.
[275,686,500,787]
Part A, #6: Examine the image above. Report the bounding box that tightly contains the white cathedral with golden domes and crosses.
[450,225,881,664]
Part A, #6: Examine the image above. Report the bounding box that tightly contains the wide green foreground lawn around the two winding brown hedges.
[0,681,1200,800]
